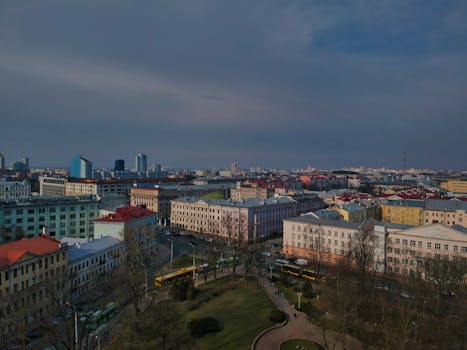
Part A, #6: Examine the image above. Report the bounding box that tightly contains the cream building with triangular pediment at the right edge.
[386,223,467,278]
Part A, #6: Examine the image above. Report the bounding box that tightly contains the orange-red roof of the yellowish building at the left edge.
[0,237,61,268]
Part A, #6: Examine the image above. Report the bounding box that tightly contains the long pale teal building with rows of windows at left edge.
[0,196,99,242]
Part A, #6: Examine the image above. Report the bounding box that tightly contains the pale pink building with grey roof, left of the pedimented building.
[282,215,360,265]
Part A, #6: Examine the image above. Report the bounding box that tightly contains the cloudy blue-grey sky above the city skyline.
[0,0,467,170]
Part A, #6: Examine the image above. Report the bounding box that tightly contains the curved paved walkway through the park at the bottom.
[252,278,363,350]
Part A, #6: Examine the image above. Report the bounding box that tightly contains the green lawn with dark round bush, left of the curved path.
[185,278,275,350]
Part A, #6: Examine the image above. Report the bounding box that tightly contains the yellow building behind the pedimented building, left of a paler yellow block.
[380,200,425,226]
